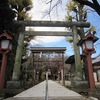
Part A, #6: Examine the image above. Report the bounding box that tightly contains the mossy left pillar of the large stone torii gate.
[12,26,25,81]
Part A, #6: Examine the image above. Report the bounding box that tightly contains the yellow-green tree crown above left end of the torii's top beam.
[9,0,32,20]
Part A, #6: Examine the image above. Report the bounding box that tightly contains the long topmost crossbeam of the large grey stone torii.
[14,21,90,27]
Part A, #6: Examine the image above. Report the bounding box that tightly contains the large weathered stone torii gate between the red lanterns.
[12,21,90,81]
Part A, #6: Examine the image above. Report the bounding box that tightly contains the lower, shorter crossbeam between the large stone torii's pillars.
[25,31,73,36]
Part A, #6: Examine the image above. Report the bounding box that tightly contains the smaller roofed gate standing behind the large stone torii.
[30,47,66,85]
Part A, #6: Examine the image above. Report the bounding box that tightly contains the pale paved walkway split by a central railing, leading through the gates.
[6,80,86,100]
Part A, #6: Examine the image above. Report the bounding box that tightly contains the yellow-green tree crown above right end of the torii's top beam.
[66,0,87,21]
